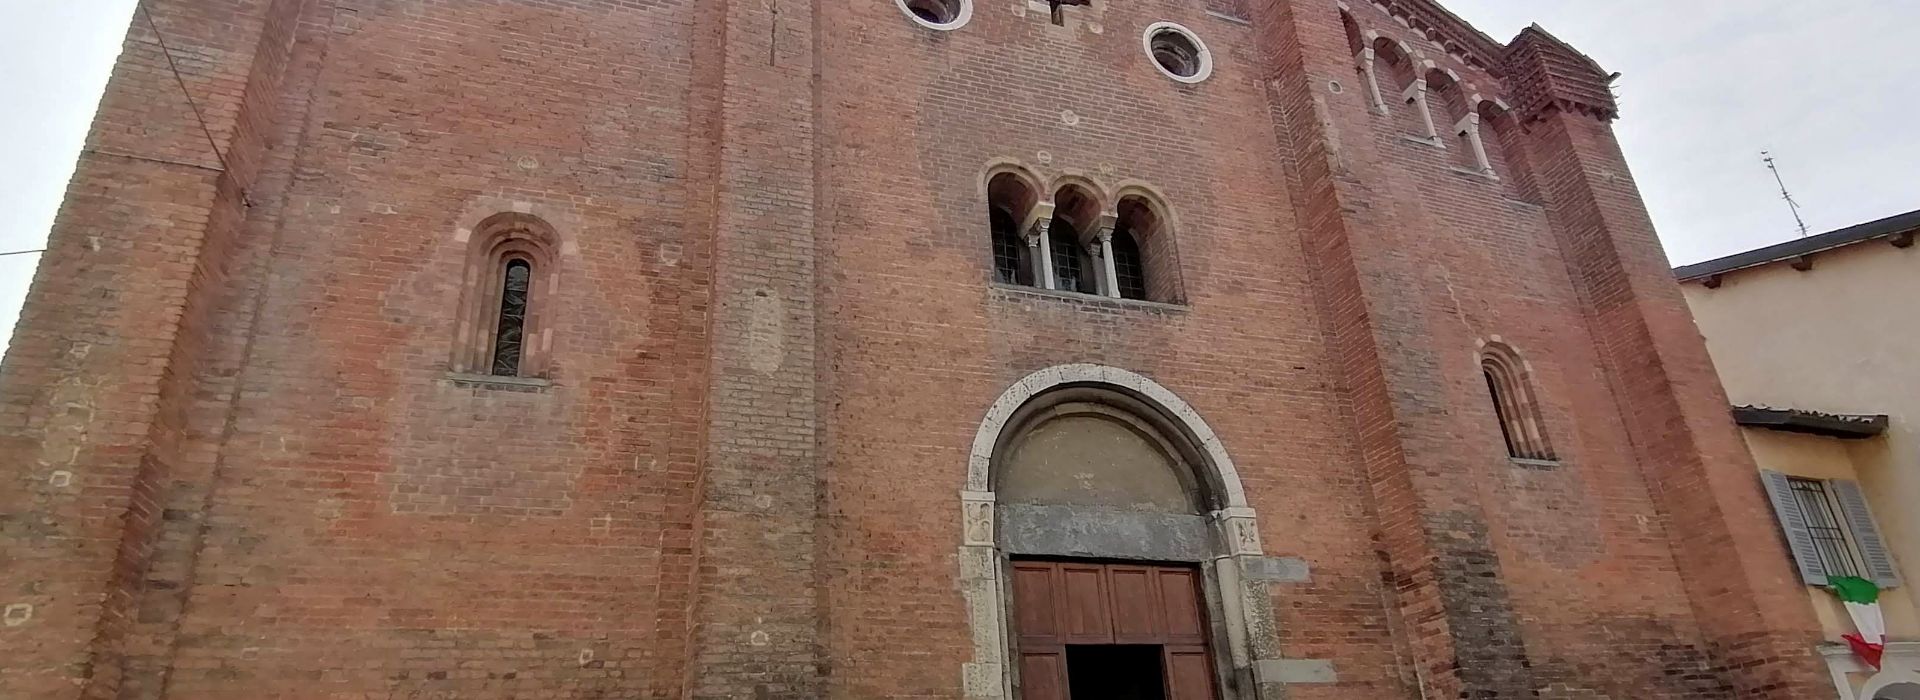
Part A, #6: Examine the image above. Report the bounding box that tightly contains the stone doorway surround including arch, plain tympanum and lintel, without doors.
[960,364,1279,700]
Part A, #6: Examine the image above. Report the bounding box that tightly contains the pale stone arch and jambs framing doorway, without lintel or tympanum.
[960,364,1281,700]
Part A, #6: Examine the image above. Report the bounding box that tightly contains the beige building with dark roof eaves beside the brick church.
[1676,211,1920,700]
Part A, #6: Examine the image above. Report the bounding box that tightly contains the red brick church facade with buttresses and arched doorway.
[0,0,1832,700]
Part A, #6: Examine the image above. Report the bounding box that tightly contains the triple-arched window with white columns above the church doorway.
[987,171,1179,303]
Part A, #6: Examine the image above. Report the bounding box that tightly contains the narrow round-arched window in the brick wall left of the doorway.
[451,213,559,378]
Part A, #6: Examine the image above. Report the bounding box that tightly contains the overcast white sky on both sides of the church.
[0,0,1920,354]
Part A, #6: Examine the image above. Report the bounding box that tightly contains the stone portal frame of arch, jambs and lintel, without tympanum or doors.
[960,364,1306,700]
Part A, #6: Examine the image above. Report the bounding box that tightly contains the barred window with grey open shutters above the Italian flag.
[1761,472,1901,589]
